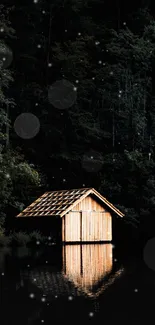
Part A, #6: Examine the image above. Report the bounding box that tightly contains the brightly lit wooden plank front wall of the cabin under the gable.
[62,196,112,242]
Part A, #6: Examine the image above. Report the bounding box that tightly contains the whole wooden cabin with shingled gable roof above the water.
[17,188,124,243]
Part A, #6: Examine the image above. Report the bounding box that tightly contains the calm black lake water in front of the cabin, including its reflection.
[0,244,155,325]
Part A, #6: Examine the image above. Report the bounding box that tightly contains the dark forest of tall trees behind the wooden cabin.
[0,0,155,243]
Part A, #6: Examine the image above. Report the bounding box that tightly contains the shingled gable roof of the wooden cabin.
[16,188,124,217]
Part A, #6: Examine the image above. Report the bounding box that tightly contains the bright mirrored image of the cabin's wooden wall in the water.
[63,244,113,296]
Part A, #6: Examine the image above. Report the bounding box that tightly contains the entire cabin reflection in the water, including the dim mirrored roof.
[21,244,123,298]
